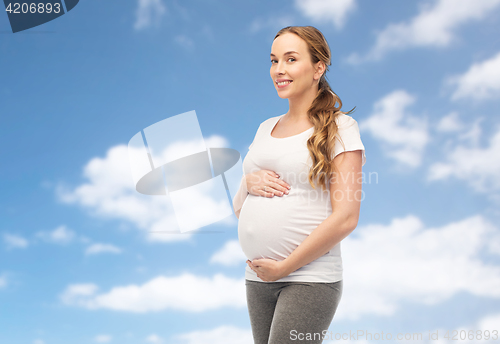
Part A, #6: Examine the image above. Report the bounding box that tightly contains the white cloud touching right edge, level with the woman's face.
[445,52,500,101]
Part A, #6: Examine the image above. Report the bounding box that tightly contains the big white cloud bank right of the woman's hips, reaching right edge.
[342,215,500,320]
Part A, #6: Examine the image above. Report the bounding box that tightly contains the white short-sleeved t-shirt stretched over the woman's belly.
[238,114,366,282]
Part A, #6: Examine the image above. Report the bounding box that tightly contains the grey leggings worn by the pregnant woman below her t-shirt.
[245,279,343,344]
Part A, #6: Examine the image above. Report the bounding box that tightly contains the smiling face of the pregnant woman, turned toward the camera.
[271,33,321,99]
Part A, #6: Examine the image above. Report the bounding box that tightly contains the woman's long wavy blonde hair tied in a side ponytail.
[274,26,356,194]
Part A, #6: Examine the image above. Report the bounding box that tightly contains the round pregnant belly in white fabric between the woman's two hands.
[238,193,324,261]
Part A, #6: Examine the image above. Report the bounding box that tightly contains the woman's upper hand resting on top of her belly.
[245,170,290,197]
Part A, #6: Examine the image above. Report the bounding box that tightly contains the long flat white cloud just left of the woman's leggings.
[60,273,246,313]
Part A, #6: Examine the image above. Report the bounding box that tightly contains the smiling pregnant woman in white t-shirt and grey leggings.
[233,26,366,344]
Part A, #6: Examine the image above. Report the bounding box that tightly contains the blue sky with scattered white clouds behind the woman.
[0,0,500,344]
